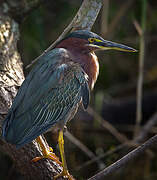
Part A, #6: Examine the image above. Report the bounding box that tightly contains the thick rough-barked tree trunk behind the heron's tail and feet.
[0,1,63,179]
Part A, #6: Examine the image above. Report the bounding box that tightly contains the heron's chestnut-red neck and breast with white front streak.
[56,38,99,89]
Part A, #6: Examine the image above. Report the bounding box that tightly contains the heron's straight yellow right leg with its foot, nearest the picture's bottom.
[54,130,74,180]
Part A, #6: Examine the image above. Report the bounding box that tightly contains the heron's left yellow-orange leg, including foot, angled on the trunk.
[32,136,62,165]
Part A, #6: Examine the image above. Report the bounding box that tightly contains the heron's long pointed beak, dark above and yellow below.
[90,40,137,52]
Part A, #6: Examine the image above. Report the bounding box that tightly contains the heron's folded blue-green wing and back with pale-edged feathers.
[2,50,89,146]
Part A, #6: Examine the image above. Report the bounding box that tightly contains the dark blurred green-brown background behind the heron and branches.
[0,0,157,180]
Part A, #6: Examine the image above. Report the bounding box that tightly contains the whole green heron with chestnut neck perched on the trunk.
[2,30,136,180]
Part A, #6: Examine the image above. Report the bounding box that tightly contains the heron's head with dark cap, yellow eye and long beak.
[60,30,136,52]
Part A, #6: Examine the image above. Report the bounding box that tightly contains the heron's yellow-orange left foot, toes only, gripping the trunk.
[32,147,62,165]
